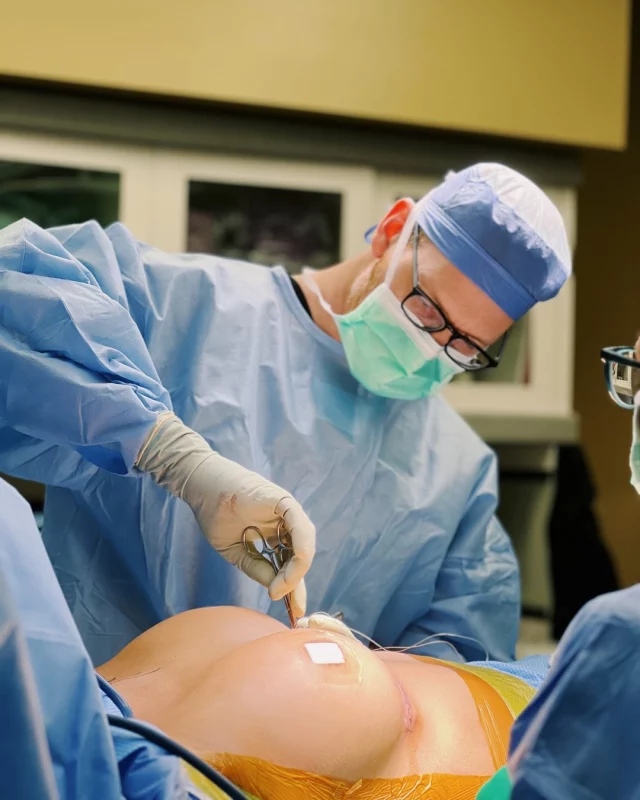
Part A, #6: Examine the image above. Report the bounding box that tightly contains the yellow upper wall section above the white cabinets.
[0,0,630,148]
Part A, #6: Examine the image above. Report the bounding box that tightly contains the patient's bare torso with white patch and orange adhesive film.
[98,607,533,800]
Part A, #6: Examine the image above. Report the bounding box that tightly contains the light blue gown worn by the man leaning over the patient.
[0,221,519,663]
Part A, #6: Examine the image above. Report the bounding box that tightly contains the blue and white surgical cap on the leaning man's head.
[418,164,571,320]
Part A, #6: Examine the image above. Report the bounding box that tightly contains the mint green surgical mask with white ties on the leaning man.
[303,197,463,400]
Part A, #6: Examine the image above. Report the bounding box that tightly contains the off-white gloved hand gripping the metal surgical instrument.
[136,413,316,617]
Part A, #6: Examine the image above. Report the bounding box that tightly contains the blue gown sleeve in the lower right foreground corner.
[508,586,640,800]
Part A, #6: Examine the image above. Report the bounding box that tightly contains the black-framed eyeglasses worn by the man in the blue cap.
[402,225,508,372]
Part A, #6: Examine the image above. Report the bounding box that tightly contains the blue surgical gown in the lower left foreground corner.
[0,479,218,800]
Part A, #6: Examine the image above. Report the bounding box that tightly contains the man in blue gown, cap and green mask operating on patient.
[0,164,571,663]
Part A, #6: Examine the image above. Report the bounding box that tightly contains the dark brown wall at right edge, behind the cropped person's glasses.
[575,6,640,584]
